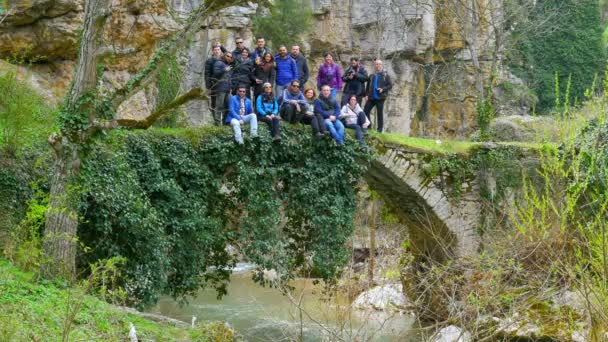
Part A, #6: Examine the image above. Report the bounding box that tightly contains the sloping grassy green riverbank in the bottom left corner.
[0,260,232,341]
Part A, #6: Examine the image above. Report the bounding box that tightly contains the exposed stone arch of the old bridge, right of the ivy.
[365,139,527,261]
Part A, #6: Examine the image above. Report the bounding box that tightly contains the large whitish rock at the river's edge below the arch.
[353,284,407,310]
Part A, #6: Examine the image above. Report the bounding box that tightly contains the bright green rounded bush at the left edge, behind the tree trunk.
[0,72,54,154]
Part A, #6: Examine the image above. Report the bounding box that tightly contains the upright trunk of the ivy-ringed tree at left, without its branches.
[41,0,110,279]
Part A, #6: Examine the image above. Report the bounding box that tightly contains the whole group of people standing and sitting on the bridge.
[205,37,392,145]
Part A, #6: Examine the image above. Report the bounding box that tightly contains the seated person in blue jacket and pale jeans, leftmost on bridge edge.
[226,86,258,144]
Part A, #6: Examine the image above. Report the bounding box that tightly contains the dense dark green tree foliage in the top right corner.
[510,0,606,112]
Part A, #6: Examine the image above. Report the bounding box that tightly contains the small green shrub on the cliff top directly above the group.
[253,0,313,49]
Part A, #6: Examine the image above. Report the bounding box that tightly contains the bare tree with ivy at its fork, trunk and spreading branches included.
[42,0,262,278]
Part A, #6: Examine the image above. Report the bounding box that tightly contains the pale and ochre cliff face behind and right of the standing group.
[309,0,500,137]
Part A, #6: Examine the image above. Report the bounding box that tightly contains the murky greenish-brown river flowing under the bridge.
[146,264,413,341]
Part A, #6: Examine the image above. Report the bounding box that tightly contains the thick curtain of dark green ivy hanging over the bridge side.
[78,127,366,303]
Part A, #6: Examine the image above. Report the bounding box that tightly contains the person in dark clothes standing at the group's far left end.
[211,52,234,126]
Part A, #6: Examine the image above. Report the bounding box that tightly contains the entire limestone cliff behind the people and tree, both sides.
[0,0,512,137]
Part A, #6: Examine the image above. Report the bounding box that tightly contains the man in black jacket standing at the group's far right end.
[363,59,393,133]
